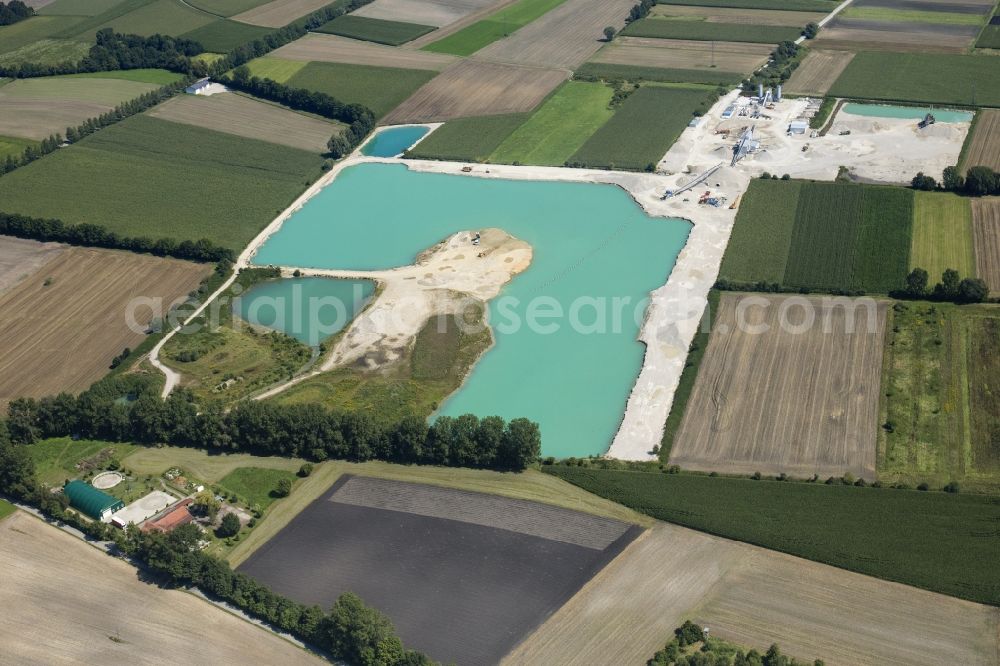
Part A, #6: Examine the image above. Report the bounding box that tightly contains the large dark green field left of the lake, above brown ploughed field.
[0,115,322,250]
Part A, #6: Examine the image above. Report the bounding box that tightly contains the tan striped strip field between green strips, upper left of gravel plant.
[591,37,772,73]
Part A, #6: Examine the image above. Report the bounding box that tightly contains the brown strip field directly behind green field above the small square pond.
[270,32,458,69]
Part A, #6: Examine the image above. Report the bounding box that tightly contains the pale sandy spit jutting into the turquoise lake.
[257,229,532,399]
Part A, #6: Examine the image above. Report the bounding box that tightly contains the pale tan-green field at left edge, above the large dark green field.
[0,76,159,141]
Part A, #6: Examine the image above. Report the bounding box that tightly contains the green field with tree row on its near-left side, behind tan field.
[287,62,438,117]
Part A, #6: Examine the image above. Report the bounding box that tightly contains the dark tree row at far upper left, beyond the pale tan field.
[0,28,205,79]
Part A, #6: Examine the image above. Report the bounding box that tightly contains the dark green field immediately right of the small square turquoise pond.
[408,113,531,162]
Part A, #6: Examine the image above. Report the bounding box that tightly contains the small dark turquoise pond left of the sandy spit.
[233,277,375,347]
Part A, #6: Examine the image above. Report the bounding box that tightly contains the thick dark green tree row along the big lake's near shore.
[7,375,541,471]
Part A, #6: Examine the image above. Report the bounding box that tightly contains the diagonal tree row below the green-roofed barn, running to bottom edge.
[0,421,433,666]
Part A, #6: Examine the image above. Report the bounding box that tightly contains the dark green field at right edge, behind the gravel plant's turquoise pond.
[828,52,1000,106]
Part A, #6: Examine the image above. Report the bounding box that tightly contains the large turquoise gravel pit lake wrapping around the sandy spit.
[254,164,691,458]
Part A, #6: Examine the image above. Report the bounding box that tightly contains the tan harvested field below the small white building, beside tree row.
[149,93,344,153]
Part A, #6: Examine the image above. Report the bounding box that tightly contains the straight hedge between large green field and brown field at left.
[0,212,235,262]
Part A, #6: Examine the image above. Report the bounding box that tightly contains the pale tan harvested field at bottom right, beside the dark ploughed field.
[504,523,1000,666]
